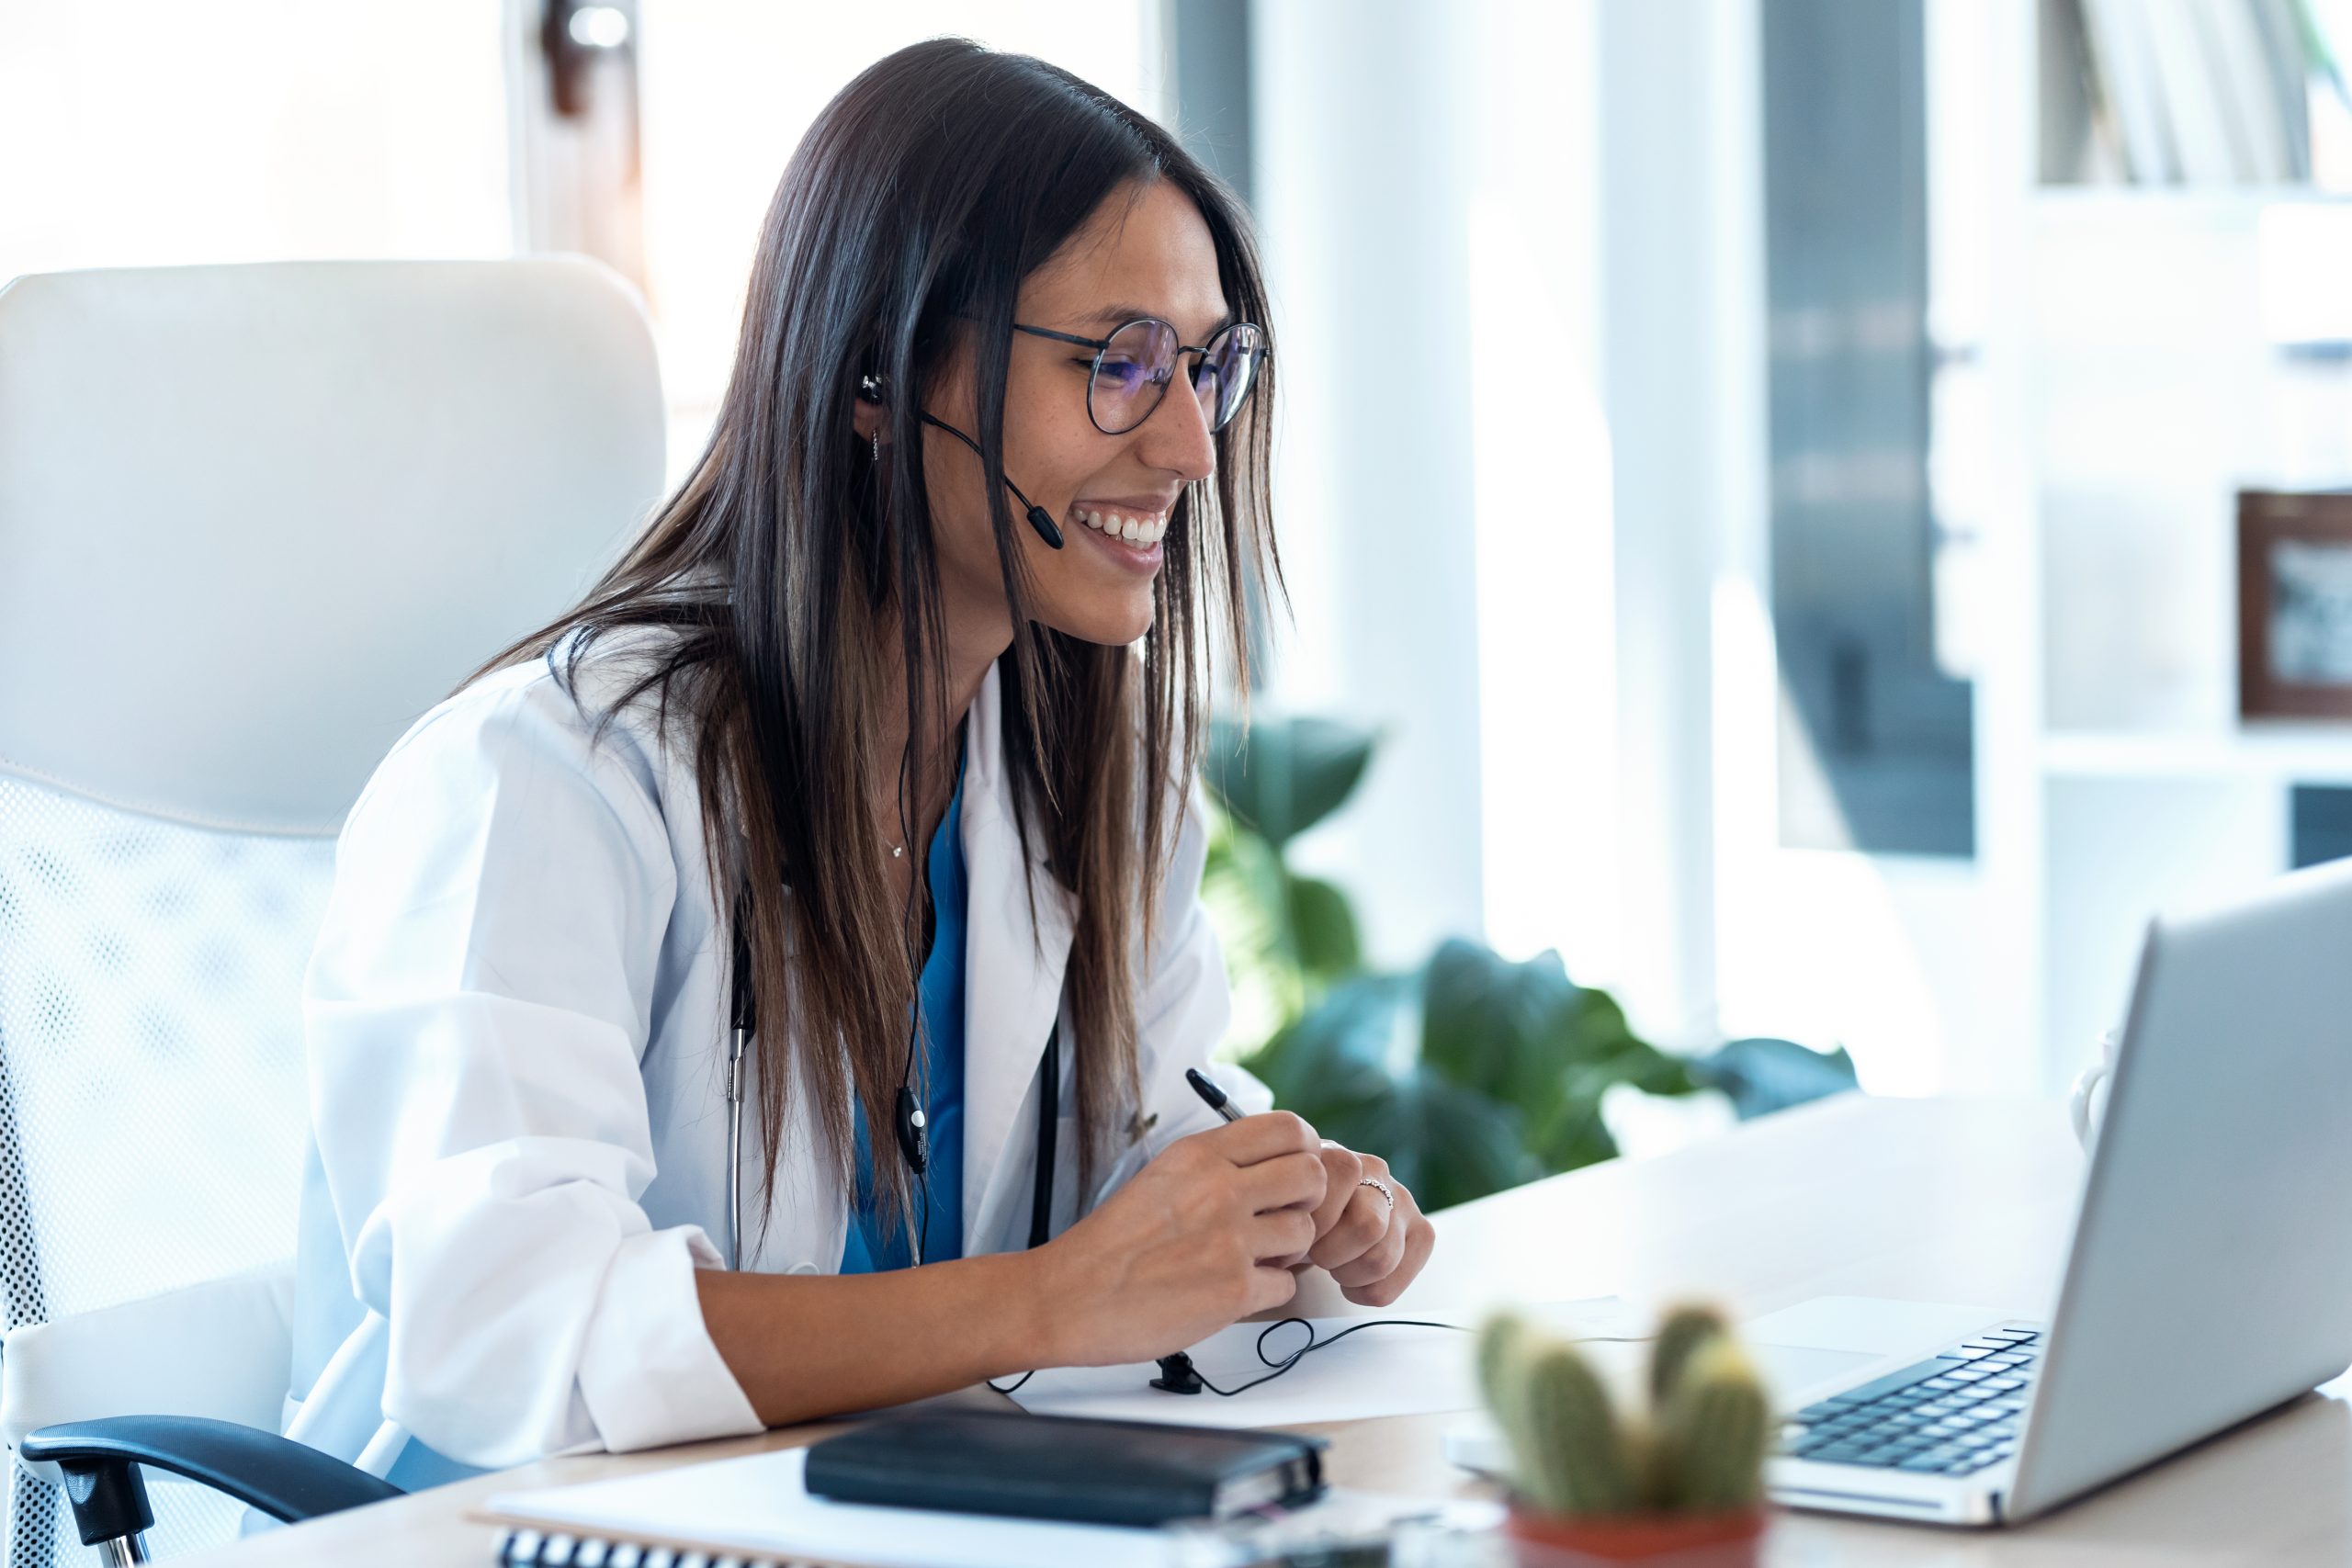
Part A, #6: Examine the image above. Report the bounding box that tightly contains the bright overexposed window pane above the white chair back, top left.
[0,0,513,277]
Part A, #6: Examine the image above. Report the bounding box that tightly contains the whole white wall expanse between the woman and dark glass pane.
[1253,0,1759,1042]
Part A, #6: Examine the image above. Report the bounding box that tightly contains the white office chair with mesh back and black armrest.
[0,256,663,1568]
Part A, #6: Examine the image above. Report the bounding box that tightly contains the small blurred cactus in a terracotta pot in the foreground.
[1477,1304,1773,1568]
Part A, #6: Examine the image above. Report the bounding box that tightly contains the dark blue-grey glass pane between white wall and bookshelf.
[1761,0,1975,856]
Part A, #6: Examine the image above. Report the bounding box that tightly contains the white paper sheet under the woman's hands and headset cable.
[1013,1295,1646,1427]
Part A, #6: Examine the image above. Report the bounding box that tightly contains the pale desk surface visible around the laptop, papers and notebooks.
[183,1096,2352,1568]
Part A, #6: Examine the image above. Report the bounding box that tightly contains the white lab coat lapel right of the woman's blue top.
[957,660,1075,1256]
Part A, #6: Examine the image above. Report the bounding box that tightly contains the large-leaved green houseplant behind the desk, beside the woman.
[1202,717,1853,1208]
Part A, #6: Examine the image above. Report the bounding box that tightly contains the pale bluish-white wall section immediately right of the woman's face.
[1251,0,1482,966]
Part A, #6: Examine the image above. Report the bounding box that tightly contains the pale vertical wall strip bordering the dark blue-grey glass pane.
[1597,0,1764,1043]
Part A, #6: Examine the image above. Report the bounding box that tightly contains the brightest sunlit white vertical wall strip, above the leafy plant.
[1463,0,1625,1001]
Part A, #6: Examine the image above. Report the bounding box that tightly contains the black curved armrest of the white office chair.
[17,1416,402,1547]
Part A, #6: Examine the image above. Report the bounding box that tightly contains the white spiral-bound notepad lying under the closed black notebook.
[487,1448,1449,1568]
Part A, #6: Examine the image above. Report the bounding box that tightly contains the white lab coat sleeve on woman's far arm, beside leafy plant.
[1117,781,1275,1178]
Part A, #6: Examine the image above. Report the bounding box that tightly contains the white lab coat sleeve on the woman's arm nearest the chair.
[303,682,760,1467]
